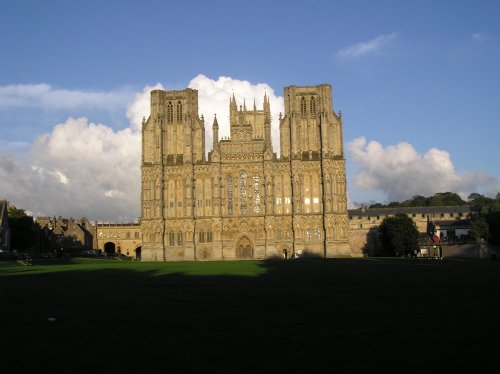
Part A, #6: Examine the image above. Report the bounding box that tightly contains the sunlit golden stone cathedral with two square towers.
[140,84,351,261]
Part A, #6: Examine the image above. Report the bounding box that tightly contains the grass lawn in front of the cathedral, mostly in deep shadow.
[0,259,500,374]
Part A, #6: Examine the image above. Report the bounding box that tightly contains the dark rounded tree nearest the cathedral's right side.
[379,214,420,256]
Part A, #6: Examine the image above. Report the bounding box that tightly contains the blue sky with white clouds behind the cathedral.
[0,0,500,222]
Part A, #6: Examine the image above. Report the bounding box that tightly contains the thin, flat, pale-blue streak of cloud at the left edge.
[0,83,132,110]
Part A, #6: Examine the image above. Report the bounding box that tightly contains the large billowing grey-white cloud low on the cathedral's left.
[0,118,140,221]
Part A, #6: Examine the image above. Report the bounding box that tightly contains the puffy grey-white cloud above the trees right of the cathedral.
[347,137,498,201]
